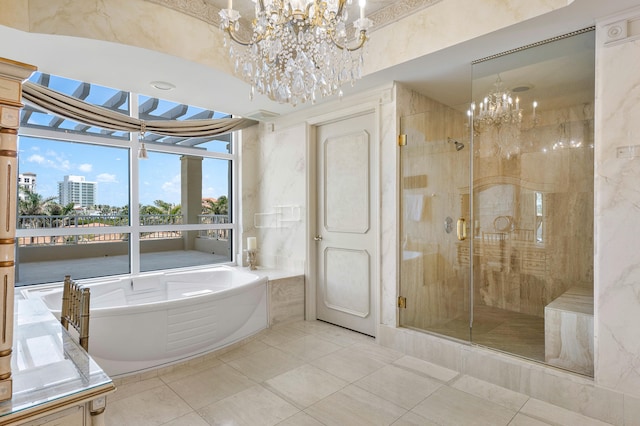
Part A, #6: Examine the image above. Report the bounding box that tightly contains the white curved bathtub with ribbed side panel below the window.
[34,266,268,376]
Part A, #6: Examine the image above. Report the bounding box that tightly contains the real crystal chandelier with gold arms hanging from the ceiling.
[220,0,372,106]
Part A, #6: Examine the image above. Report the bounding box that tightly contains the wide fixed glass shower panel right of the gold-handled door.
[472,30,595,375]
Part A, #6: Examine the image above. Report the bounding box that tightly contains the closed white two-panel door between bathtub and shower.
[315,113,377,336]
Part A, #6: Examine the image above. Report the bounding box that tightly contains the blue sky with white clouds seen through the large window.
[18,73,229,207]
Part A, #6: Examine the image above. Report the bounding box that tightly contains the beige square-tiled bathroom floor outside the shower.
[106,321,616,426]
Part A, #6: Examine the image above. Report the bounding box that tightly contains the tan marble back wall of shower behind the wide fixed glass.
[474,101,594,317]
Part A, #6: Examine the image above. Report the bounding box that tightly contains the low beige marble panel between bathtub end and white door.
[269,275,304,326]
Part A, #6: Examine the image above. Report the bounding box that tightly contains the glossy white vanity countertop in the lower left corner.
[0,298,115,424]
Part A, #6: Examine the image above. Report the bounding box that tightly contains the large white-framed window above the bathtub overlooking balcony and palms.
[16,73,235,286]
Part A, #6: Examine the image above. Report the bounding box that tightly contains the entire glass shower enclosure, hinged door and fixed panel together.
[399,29,595,376]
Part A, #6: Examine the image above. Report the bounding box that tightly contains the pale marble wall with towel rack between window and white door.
[241,123,307,274]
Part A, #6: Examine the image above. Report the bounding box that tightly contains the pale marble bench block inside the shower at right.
[544,286,593,377]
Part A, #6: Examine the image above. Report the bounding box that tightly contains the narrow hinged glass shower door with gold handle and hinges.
[400,110,470,341]
